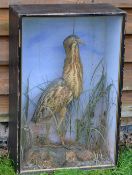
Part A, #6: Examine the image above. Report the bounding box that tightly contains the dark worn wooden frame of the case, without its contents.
[8,4,126,173]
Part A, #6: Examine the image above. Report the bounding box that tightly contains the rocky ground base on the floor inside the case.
[22,144,112,170]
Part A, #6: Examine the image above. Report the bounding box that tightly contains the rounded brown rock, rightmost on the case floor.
[77,150,93,161]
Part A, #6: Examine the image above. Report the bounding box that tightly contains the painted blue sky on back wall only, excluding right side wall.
[22,18,105,93]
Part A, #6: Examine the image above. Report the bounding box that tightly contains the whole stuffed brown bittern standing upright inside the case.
[32,35,83,144]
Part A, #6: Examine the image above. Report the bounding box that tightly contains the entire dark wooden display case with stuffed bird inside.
[9,4,126,173]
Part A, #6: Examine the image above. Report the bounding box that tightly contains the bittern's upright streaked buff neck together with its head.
[63,35,83,98]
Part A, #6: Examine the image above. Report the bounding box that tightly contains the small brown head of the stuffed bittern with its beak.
[63,35,83,51]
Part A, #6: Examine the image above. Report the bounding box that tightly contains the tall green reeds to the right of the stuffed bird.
[76,60,112,147]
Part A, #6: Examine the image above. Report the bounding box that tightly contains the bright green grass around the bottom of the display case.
[0,148,132,175]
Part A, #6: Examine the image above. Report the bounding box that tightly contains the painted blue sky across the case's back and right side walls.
[22,17,121,121]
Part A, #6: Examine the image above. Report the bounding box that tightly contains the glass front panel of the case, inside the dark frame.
[20,16,122,171]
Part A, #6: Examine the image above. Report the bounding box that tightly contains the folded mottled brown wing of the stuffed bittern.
[32,79,73,122]
